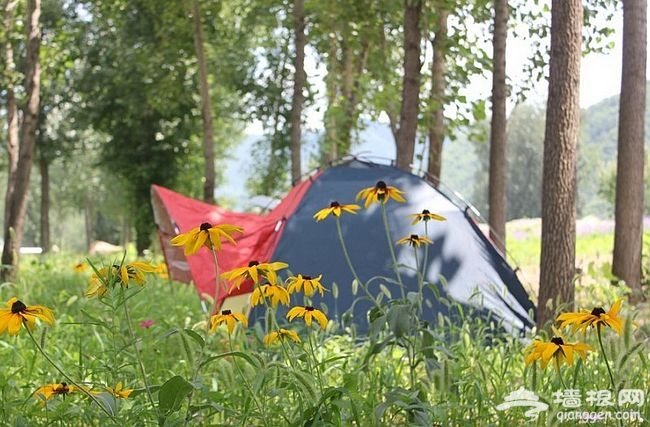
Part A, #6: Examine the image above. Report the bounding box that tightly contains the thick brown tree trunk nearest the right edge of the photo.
[612,0,648,302]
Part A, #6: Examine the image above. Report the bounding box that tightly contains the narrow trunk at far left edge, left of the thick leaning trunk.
[3,0,19,230]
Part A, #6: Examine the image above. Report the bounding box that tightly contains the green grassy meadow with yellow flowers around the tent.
[0,221,650,426]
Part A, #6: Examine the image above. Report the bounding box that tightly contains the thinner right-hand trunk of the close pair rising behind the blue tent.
[427,8,449,186]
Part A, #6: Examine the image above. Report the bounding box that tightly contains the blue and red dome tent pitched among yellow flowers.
[152,159,534,331]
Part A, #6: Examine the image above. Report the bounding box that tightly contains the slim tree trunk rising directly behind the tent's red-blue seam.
[290,0,307,184]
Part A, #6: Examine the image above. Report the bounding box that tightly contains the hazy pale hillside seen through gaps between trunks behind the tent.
[217,83,650,214]
